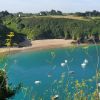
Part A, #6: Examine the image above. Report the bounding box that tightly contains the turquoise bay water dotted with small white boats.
[3,46,100,100]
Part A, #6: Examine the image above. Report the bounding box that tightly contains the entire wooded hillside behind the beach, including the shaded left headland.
[0,11,100,46]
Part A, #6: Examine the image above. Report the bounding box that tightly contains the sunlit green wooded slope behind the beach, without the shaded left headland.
[8,17,100,42]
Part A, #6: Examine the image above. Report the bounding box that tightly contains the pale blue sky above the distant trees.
[0,0,100,13]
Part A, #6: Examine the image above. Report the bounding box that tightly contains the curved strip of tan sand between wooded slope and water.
[0,39,77,53]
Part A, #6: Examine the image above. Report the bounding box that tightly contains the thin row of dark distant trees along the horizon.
[0,9,100,18]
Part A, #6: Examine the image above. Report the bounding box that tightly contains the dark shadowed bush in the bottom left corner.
[0,69,21,100]
